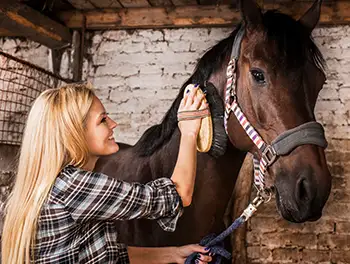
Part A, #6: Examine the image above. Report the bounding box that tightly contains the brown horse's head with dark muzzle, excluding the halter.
[220,0,331,222]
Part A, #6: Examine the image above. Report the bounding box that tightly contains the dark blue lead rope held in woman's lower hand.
[185,216,245,264]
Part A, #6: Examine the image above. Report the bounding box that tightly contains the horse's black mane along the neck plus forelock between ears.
[134,11,324,156]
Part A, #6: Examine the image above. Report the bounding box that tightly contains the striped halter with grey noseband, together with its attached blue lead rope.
[185,27,327,264]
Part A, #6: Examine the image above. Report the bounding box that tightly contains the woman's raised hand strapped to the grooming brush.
[178,87,208,138]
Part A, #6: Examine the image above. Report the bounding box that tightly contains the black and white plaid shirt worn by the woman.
[33,166,183,264]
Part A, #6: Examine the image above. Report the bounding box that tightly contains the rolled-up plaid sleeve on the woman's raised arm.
[63,170,183,231]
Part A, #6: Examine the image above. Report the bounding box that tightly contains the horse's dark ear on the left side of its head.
[239,0,262,28]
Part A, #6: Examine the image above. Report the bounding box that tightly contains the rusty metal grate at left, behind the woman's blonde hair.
[0,51,70,145]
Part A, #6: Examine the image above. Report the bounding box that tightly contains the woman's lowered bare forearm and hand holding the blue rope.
[128,244,212,264]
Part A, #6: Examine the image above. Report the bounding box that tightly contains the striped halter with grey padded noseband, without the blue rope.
[224,26,327,202]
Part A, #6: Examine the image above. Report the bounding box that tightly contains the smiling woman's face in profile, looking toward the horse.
[85,96,119,160]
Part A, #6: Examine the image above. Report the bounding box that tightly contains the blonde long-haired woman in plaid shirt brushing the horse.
[2,84,211,264]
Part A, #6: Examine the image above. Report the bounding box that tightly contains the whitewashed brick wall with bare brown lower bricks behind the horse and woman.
[0,26,350,264]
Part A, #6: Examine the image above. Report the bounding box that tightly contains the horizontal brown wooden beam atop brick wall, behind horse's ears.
[58,1,350,30]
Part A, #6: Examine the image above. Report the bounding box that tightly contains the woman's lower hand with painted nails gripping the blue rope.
[175,244,212,264]
